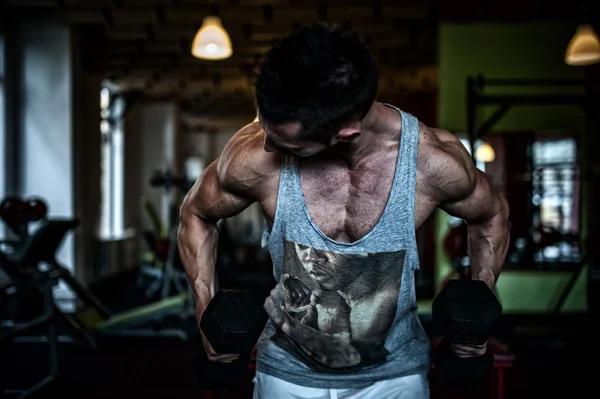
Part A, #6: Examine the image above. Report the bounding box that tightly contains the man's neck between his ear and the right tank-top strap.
[332,102,401,170]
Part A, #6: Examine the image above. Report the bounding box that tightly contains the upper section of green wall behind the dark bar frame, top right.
[439,22,584,133]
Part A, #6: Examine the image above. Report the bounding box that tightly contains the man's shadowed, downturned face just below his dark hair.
[261,122,328,158]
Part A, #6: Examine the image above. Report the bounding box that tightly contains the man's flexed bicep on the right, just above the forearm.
[439,166,502,223]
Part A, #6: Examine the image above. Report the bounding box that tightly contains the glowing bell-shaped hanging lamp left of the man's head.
[192,17,233,60]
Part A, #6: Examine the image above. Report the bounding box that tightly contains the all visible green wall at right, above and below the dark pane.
[422,22,587,313]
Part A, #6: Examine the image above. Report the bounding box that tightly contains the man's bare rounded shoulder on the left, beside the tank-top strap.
[217,122,280,193]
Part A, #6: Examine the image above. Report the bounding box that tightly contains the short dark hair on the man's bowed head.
[256,24,378,141]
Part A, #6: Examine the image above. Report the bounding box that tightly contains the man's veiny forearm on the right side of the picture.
[468,197,510,288]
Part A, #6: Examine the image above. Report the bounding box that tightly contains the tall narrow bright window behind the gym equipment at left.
[100,87,125,239]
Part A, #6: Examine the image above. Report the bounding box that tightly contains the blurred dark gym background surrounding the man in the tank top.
[0,0,600,399]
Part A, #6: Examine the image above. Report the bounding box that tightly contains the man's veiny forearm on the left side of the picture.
[177,211,219,305]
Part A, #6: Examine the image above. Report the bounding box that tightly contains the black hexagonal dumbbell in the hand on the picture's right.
[433,280,502,385]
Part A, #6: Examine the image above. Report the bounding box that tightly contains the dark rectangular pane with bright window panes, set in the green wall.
[487,131,581,270]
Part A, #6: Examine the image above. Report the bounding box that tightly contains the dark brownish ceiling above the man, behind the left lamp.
[7,0,592,115]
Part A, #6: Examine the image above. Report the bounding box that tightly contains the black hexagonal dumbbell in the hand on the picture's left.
[194,290,268,390]
